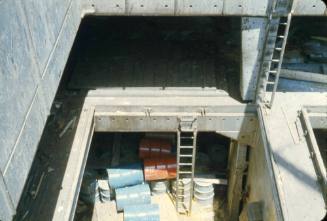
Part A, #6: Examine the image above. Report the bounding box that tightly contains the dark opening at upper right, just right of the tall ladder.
[276,17,327,92]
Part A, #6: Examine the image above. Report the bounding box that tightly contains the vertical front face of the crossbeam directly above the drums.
[94,105,257,144]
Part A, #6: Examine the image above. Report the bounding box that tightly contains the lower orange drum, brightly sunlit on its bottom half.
[144,155,177,181]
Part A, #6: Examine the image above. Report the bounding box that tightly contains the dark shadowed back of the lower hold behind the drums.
[87,132,230,176]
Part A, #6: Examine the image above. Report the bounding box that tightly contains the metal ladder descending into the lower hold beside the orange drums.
[176,117,197,215]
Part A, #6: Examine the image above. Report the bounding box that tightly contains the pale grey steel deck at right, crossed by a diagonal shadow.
[258,92,327,221]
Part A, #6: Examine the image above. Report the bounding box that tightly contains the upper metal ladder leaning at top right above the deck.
[256,0,293,108]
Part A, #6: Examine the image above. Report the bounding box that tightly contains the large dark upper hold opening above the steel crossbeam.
[68,16,241,100]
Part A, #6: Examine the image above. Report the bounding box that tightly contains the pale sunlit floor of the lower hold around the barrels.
[75,194,225,221]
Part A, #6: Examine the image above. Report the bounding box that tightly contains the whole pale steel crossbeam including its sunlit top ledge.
[90,90,256,144]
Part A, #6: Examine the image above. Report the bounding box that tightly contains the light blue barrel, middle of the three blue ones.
[115,184,151,211]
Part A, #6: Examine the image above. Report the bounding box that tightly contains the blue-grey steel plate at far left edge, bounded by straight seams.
[0,1,39,172]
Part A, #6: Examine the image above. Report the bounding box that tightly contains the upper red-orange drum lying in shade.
[139,138,171,159]
